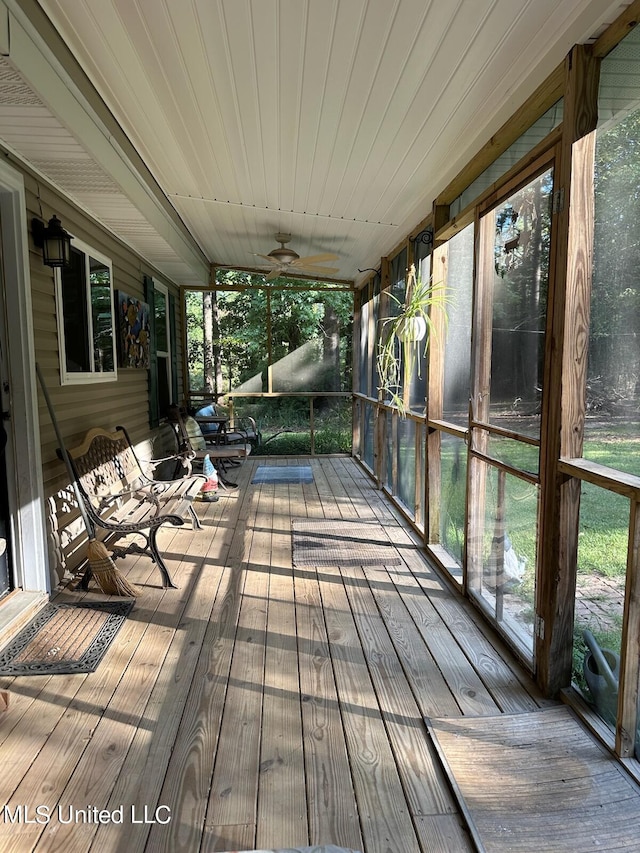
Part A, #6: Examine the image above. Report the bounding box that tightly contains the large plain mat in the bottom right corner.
[426,705,640,853]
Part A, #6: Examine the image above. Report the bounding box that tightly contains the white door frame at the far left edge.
[0,162,51,593]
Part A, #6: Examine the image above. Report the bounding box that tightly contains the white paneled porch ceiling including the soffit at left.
[0,0,628,283]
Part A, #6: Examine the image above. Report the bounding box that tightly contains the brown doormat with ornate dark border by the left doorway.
[0,601,134,675]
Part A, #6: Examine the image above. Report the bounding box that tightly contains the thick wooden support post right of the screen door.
[535,45,600,696]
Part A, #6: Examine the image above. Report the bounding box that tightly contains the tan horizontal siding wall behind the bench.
[16,161,182,586]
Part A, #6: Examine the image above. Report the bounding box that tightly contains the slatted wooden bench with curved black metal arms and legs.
[69,427,205,588]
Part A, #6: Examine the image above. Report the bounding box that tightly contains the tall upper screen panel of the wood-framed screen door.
[489,169,553,436]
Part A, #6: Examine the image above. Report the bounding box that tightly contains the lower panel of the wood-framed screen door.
[468,459,538,658]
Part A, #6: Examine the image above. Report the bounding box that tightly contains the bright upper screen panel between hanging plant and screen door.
[443,225,473,426]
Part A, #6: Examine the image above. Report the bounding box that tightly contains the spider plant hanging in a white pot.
[377,264,448,416]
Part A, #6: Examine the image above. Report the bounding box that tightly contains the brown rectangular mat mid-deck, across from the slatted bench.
[291,518,402,566]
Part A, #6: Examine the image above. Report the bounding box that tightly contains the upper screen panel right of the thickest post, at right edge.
[584,28,640,474]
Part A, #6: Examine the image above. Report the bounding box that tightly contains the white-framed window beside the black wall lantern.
[56,240,116,385]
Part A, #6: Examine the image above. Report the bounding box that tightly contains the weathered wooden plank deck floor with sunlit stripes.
[0,458,556,853]
